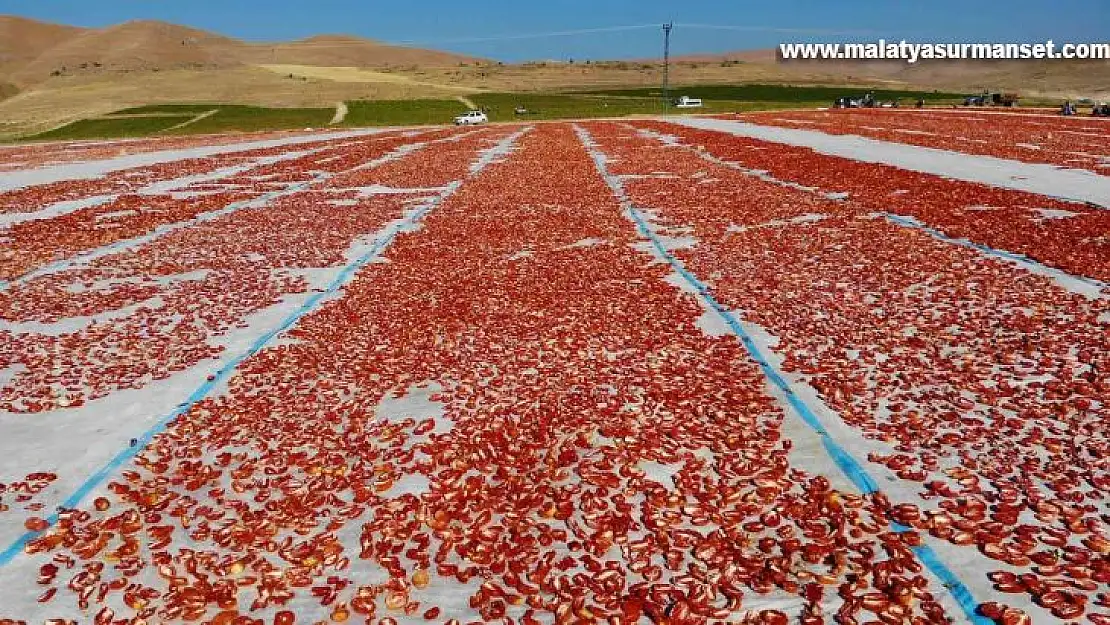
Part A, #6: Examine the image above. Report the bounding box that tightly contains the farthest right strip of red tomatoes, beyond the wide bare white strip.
[723,109,1110,174]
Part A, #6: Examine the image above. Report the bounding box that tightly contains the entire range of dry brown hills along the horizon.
[0,16,1110,137]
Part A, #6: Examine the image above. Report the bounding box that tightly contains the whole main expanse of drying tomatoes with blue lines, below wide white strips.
[0,113,1110,625]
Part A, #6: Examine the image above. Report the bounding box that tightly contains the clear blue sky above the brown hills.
[0,0,1110,61]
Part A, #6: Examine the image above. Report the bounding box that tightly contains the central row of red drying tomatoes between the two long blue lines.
[11,125,981,625]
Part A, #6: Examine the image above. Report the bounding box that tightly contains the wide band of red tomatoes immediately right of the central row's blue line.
[594,123,1110,622]
